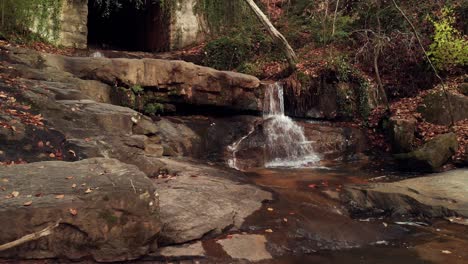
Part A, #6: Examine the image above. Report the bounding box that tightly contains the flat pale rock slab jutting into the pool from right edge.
[341,169,468,217]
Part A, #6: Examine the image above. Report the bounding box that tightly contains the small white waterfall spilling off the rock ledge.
[263,83,320,167]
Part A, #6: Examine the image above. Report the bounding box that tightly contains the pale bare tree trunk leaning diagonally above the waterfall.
[245,0,297,70]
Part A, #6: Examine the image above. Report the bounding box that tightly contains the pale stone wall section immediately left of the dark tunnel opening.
[57,0,88,49]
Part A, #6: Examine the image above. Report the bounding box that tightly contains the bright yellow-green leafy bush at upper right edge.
[429,6,468,70]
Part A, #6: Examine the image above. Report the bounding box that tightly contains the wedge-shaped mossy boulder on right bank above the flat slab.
[395,133,458,171]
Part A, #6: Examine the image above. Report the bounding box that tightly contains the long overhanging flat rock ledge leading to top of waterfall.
[5,47,263,111]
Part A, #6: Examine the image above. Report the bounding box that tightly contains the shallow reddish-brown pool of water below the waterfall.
[201,163,468,264]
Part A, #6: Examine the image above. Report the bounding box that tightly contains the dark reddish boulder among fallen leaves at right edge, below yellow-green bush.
[418,91,468,125]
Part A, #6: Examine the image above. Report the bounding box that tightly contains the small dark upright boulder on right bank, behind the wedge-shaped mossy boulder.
[388,116,417,153]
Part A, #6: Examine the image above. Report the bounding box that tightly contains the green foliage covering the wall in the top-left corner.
[0,0,64,43]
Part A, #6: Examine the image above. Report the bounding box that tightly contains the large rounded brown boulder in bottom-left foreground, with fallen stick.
[0,158,161,261]
